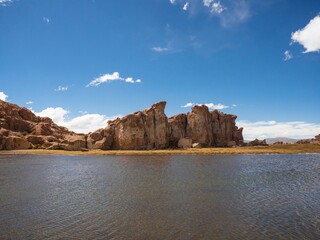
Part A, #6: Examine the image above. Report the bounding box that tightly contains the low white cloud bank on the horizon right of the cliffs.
[237,121,320,140]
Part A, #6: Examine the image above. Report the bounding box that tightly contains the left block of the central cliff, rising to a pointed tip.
[88,102,169,150]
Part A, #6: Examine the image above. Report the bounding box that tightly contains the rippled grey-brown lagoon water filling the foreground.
[0,154,320,239]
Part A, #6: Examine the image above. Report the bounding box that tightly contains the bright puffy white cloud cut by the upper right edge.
[291,15,320,53]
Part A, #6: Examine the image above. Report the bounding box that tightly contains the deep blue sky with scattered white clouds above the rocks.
[0,0,320,139]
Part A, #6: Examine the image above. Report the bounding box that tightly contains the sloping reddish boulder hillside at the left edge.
[0,100,87,150]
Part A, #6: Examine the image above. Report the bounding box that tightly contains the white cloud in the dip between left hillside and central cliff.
[35,107,119,133]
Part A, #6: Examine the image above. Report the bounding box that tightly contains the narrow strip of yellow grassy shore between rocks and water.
[0,144,320,156]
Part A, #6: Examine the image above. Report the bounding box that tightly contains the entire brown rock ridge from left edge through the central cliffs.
[0,100,243,150]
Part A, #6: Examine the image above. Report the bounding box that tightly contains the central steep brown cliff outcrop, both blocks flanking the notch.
[87,102,243,150]
